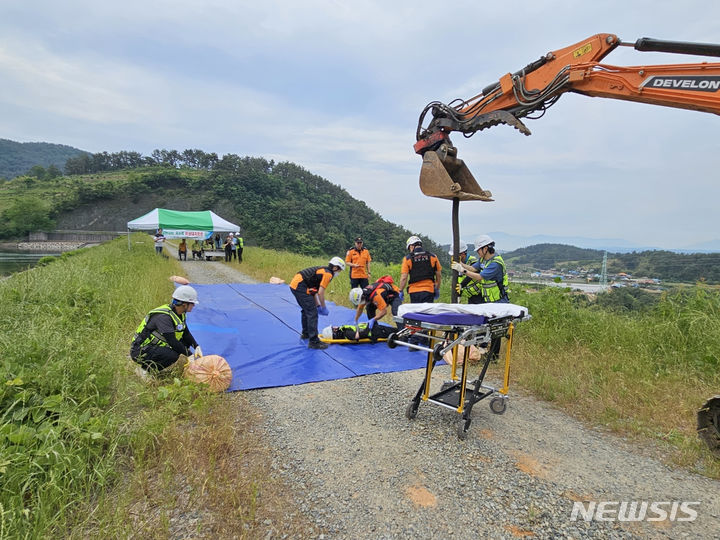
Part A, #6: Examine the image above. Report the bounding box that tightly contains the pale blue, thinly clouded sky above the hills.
[0,0,720,249]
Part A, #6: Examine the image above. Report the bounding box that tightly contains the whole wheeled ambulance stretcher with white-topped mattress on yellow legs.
[387,304,530,439]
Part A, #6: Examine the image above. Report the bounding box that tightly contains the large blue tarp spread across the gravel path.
[188,283,427,391]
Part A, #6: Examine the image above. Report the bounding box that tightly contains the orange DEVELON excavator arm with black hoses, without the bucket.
[414,34,720,155]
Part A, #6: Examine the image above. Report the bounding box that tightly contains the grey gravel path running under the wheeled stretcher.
[183,262,720,539]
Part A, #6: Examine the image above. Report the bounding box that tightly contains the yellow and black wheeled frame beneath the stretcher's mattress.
[387,312,530,440]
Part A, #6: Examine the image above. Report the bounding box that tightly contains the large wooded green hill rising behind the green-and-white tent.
[0,151,449,264]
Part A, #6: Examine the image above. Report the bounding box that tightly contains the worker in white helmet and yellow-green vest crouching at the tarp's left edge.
[130,285,198,372]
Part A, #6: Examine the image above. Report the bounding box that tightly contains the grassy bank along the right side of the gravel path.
[229,247,720,478]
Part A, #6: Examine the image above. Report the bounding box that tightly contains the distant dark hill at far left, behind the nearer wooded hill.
[0,139,86,180]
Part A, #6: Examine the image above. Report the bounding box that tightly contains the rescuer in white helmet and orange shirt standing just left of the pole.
[398,236,442,304]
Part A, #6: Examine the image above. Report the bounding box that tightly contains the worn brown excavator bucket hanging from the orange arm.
[420,148,493,201]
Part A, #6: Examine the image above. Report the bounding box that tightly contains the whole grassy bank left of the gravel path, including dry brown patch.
[0,234,306,538]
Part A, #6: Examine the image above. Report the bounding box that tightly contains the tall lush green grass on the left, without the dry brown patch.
[0,235,222,538]
